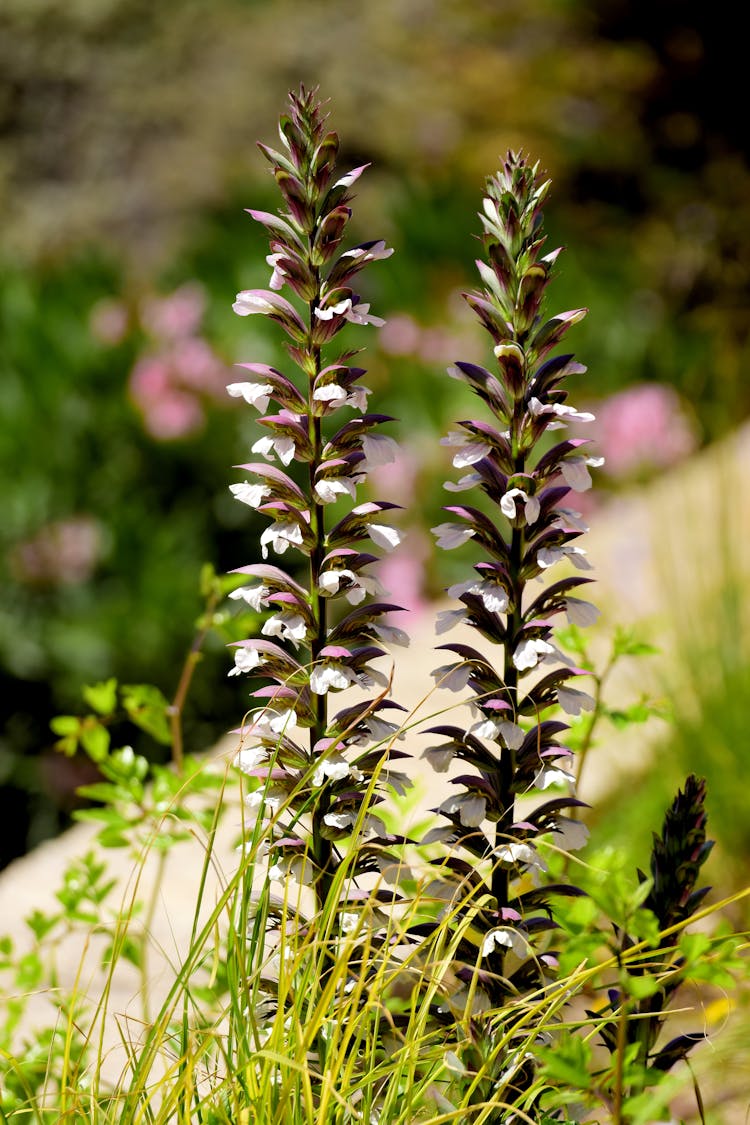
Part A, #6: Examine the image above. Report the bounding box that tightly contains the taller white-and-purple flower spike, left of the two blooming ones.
[227,89,403,907]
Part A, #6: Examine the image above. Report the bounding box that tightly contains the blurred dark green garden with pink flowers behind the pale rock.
[0,0,750,862]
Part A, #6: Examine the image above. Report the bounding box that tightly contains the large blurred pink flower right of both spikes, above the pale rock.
[589,383,696,477]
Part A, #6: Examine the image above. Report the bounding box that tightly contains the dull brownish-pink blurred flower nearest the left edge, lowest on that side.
[11,515,103,586]
